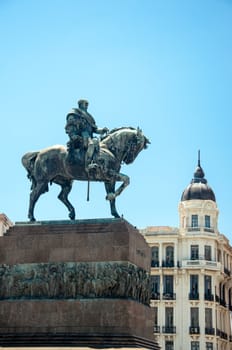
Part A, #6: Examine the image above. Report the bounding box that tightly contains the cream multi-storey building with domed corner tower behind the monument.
[141,159,232,350]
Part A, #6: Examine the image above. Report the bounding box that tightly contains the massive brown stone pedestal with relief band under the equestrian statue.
[0,219,159,349]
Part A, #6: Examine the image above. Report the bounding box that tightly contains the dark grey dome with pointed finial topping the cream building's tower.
[181,153,216,202]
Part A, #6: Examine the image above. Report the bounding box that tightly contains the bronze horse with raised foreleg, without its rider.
[22,127,150,221]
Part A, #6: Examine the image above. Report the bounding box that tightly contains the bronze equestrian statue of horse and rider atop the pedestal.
[22,100,150,221]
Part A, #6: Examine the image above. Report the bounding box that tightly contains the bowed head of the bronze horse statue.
[122,128,150,164]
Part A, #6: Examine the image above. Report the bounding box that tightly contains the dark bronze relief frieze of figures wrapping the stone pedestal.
[0,262,150,305]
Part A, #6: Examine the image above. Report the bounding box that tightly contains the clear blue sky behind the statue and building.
[0,0,232,238]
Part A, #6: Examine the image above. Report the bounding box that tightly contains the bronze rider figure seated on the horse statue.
[65,100,108,172]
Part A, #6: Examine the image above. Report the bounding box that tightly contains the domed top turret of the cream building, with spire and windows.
[179,151,219,235]
